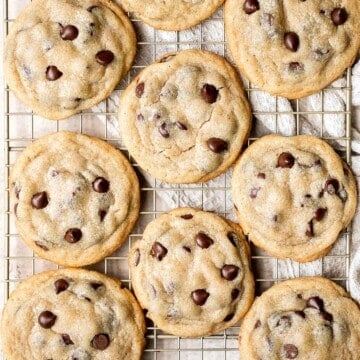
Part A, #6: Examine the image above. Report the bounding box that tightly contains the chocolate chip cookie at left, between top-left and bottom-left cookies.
[10,132,140,267]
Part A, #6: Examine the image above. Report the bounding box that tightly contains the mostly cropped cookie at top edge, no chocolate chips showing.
[121,0,224,30]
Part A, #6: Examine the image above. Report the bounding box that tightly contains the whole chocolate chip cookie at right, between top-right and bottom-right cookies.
[232,135,357,262]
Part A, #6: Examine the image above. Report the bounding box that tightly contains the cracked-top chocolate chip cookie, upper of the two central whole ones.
[119,50,250,183]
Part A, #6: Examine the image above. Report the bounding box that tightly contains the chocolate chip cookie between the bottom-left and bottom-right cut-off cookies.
[129,208,254,337]
